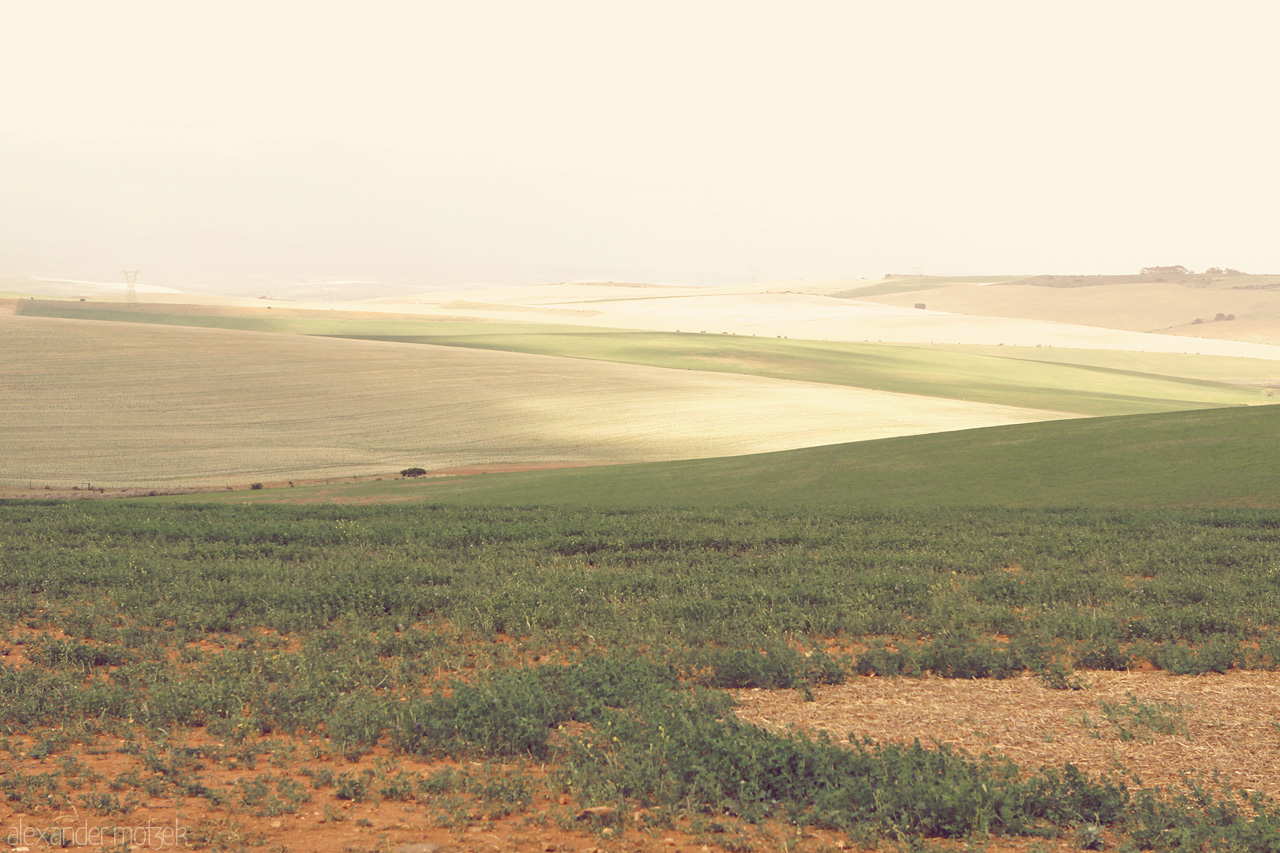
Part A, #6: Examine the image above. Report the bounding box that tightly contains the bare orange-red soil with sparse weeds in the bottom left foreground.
[0,729,841,853]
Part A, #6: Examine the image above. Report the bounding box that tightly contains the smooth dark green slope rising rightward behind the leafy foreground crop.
[209,406,1280,504]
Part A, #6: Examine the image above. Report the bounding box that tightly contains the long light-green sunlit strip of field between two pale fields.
[23,302,1280,416]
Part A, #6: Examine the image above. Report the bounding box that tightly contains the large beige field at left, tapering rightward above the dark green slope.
[0,316,1061,488]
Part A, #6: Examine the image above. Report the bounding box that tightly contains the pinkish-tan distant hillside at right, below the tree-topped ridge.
[867,282,1280,343]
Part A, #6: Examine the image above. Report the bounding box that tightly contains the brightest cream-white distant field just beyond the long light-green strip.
[348,283,1280,360]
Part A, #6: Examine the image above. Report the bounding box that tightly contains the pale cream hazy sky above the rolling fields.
[0,0,1280,284]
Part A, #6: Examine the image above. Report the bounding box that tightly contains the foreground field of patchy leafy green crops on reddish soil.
[0,502,1280,852]
